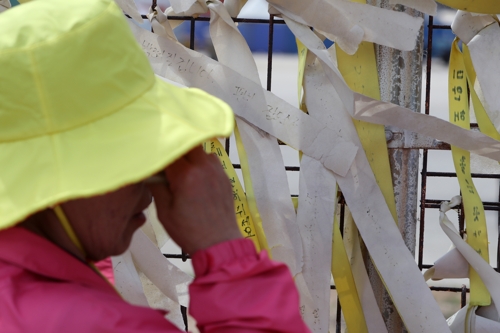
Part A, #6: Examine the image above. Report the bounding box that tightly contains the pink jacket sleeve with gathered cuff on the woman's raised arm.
[189,239,309,333]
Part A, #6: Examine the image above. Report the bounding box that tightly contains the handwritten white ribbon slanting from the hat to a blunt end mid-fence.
[125,23,358,175]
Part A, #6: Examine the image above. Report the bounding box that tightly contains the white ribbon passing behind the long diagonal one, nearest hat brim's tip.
[209,2,303,275]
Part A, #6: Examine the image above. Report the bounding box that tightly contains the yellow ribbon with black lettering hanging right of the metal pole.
[448,38,491,306]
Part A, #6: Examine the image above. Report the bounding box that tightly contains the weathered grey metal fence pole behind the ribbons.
[365,0,424,333]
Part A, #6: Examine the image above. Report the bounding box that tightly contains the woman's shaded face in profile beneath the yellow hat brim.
[61,182,152,261]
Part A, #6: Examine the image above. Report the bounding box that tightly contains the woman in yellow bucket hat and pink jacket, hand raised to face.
[0,0,308,333]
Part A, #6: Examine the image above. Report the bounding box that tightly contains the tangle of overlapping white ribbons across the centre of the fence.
[114,0,500,333]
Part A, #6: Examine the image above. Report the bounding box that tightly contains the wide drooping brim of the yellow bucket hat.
[0,78,234,229]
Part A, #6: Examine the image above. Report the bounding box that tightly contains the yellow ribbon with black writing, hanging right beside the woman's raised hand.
[203,139,269,252]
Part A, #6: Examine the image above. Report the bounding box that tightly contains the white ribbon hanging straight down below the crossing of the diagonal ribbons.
[296,156,337,332]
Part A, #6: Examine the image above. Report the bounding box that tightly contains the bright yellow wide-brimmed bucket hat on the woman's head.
[0,0,234,229]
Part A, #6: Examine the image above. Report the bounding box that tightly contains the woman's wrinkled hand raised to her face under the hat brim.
[149,147,242,254]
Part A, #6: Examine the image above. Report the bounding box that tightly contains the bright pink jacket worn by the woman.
[0,227,309,333]
